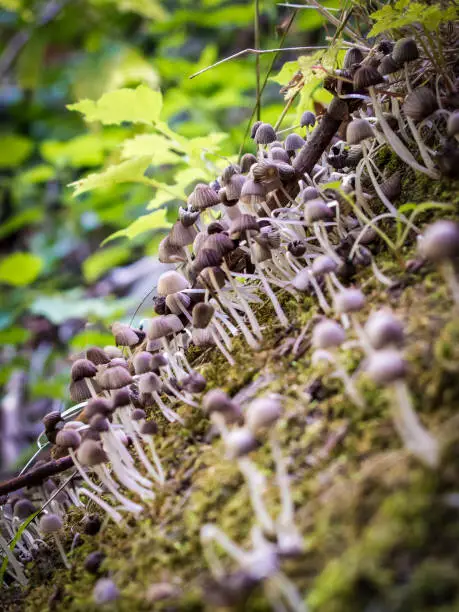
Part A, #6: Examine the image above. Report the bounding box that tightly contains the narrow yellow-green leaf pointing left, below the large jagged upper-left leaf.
[70,157,150,196]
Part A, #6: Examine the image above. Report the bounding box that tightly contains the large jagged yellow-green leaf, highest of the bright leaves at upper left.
[67,85,162,125]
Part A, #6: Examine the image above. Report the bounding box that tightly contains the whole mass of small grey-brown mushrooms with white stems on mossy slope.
[0,38,459,611]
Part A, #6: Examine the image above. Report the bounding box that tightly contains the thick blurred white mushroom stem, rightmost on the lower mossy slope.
[390,380,439,468]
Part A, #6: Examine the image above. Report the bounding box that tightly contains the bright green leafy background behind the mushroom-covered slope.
[0,0,339,450]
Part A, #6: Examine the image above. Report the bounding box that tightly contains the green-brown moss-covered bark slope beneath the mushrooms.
[2,170,459,612]
